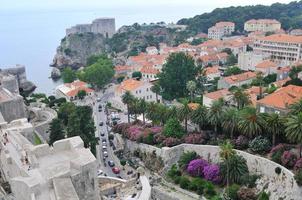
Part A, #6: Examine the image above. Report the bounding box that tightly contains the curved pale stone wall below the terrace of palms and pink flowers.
[125,140,302,200]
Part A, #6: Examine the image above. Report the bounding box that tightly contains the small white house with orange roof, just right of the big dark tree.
[203,89,232,107]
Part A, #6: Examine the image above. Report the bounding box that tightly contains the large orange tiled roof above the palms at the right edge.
[258,85,302,109]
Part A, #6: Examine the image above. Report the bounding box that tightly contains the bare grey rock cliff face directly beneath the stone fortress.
[51,33,106,69]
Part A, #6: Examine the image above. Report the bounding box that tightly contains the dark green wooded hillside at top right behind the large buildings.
[177,1,302,33]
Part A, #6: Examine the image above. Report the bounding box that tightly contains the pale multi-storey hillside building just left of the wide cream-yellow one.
[208,22,235,40]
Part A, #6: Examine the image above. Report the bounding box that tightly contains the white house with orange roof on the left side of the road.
[55,80,94,101]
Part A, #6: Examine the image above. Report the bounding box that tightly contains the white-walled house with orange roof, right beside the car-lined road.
[111,79,161,110]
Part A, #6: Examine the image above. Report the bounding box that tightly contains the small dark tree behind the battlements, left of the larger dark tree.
[48,118,65,145]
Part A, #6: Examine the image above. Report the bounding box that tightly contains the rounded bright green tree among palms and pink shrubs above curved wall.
[163,118,184,138]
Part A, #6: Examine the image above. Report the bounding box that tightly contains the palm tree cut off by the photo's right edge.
[285,112,302,158]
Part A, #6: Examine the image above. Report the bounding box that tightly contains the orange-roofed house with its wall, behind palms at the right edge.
[257,85,302,115]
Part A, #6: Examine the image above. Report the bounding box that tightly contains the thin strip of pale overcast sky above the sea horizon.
[0,0,291,11]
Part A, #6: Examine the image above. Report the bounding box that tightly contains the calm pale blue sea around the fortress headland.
[0,6,208,94]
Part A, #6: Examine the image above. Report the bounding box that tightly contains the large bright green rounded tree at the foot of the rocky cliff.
[78,56,114,88]
